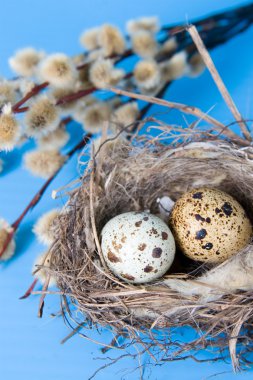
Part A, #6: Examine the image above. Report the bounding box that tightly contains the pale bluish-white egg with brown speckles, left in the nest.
[101,212,175,284]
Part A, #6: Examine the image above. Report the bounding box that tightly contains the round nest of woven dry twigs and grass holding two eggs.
[49,128,253,368]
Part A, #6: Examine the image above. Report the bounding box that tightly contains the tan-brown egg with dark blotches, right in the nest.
[170,187,252,263]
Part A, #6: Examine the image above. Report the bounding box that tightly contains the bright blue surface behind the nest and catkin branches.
[0,0,253,380]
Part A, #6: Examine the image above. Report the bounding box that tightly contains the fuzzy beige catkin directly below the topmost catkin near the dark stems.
[132,30,158,58]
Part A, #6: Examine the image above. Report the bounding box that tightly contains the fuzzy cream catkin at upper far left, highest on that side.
[9,47,45,77]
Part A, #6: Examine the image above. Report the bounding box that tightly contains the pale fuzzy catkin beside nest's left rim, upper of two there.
[33,209,60,245]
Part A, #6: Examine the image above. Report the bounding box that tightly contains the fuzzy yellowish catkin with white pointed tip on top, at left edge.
[0,106,20,151]
